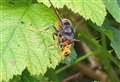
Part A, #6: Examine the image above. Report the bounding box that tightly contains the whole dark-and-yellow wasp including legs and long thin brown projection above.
[29,0,79,57]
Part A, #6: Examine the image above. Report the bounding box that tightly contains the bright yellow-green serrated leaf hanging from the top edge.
[38,0,106,26]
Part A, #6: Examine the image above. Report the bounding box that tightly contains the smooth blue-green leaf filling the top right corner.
[103,0,120,23]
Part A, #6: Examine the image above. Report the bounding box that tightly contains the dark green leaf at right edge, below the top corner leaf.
[101,26,120,59]
